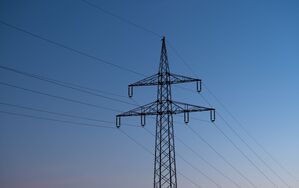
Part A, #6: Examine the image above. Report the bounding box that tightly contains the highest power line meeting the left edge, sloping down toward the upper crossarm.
[0,20,145,76]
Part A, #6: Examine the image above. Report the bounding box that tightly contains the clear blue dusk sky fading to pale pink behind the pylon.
[0,0,299,188]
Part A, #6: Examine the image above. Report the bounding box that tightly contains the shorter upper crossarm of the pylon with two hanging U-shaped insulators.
[128,73,201,97]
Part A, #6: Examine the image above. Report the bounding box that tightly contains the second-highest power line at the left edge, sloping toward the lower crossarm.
[0,65,136,106]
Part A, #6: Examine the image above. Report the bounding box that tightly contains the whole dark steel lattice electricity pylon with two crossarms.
[116,37,215,188]
